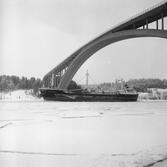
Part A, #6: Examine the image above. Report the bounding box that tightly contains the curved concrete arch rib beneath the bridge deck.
[58,29,167,89]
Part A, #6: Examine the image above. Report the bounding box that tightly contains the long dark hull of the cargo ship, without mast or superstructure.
[40,88,138,102]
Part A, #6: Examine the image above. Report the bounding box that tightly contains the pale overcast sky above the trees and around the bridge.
[0,0,167,84]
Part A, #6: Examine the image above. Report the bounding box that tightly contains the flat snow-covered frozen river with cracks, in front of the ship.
[0,101,167,167]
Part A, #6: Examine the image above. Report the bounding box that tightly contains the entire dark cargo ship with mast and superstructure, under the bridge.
[40,71,138,102]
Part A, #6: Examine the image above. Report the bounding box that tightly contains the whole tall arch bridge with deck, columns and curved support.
[43,0,167,90]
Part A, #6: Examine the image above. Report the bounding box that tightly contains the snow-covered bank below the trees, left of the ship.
[0,90,39,101]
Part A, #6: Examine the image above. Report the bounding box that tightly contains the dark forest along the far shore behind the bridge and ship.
[0,75,167,94]
